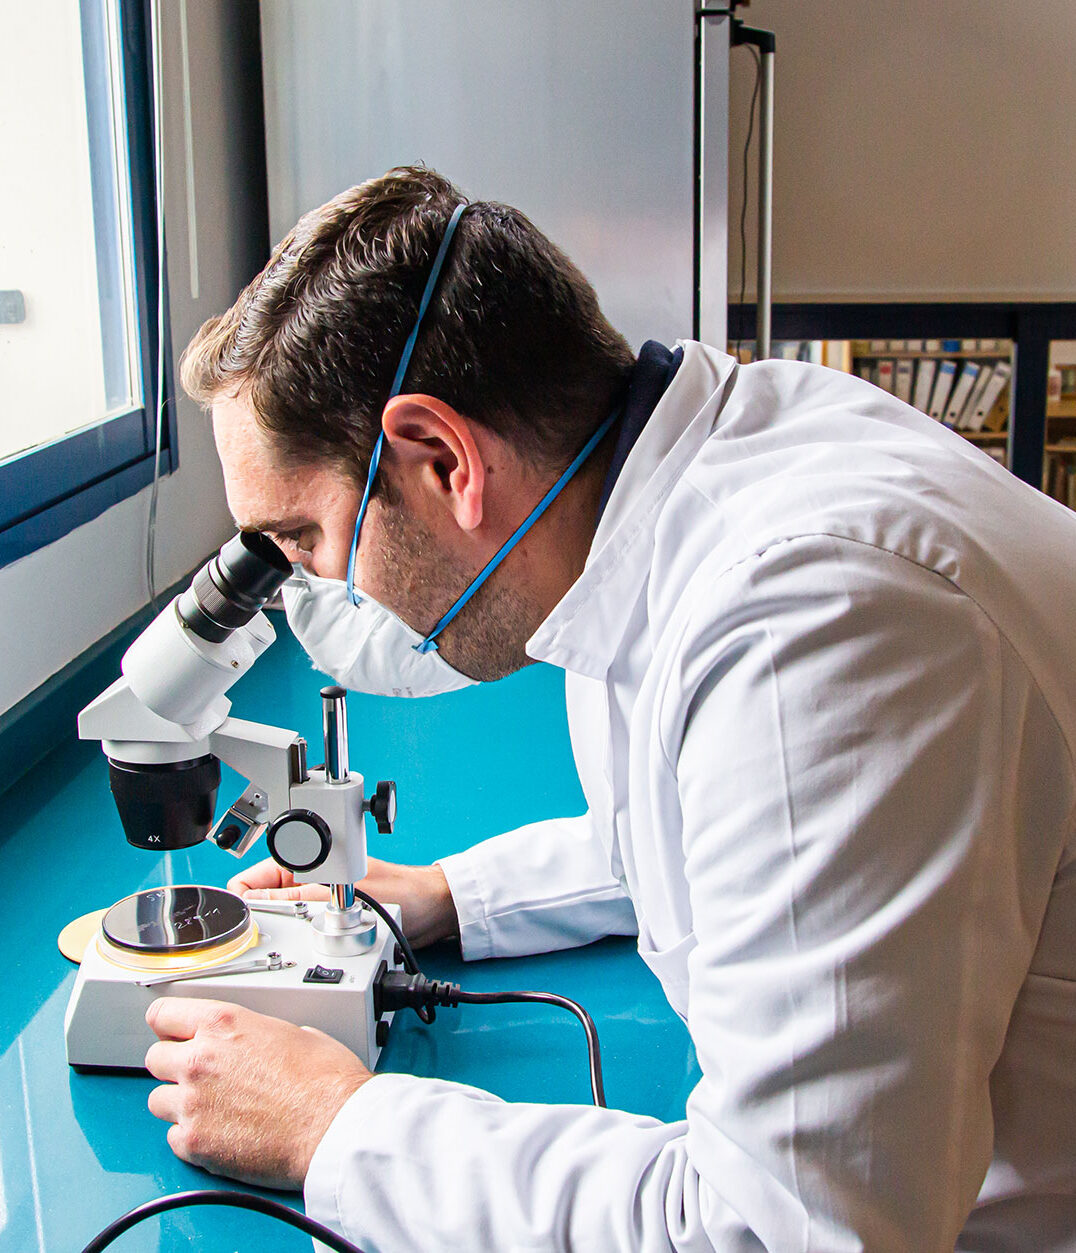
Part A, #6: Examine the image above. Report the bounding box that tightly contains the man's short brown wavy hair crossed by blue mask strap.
[180,167,634,476]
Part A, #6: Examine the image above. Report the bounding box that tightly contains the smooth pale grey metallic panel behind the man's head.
[262,0,694,347]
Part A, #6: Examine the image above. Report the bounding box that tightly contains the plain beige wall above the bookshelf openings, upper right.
[729,0,1076,301]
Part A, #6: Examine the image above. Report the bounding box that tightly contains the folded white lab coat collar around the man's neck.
[526,341,737,679]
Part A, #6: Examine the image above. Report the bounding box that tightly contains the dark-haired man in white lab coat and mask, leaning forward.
[147,169,1076,1253]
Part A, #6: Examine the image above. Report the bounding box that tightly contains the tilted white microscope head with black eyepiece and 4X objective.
[79,531,292,851]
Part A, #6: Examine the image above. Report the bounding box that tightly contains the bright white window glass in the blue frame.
[0,0,143,461]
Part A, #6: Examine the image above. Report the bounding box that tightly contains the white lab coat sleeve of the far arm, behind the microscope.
[437,813,636,961]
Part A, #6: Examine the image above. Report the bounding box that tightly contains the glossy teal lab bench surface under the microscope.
[0,614,699,1253]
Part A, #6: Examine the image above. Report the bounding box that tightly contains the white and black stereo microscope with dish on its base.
[64,533,402,1070]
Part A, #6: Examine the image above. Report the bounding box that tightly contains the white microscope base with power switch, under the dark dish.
[64,905,400,1070]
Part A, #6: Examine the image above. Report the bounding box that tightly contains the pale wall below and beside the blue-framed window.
[0,0,266,712]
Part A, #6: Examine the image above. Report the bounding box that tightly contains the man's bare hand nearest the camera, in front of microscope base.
[145,996,371,1188]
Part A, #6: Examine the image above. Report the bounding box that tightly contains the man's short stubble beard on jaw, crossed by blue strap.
[378,505,545,683]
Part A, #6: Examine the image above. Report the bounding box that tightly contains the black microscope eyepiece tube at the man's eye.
[177,531,292,644]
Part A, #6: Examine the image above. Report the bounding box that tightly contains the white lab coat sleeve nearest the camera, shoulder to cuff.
[307,540,1033,1253]
